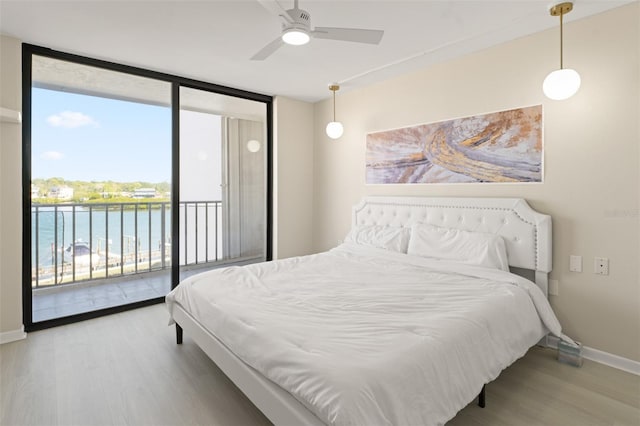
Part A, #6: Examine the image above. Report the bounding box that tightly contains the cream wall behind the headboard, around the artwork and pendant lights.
[313,2,640,361]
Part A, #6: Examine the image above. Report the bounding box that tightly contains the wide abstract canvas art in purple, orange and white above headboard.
[366,105,543,184]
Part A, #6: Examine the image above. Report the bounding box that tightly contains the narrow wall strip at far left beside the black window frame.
[0,36,22,341]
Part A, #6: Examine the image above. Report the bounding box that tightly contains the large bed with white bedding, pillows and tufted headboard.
[167,197,562,425]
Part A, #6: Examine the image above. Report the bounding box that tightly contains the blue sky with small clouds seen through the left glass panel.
[31,87,171,183]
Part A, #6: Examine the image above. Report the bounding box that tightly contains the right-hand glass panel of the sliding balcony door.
[179,87,267,278]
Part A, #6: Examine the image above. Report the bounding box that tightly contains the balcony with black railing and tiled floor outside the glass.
[31,200,238,322]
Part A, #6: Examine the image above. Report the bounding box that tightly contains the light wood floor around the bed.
[0,305,640,426]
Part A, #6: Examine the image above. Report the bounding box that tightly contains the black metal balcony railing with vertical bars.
[31,201,223,288]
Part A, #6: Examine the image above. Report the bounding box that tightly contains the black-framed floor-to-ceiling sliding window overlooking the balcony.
[23,45,271,330]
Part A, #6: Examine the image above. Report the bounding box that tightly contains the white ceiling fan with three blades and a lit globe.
[251,0,384,61]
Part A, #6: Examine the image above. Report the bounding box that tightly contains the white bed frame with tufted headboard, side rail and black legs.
[173,197,551,425]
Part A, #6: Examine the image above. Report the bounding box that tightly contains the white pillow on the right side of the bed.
[407,224,509,271]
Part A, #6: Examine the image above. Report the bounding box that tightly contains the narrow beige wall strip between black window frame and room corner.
[273,96,314,259]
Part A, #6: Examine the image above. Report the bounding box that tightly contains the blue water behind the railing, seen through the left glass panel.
[31,203,171,285]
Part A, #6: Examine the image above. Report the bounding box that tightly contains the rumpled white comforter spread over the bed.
[167,244,560,425]
